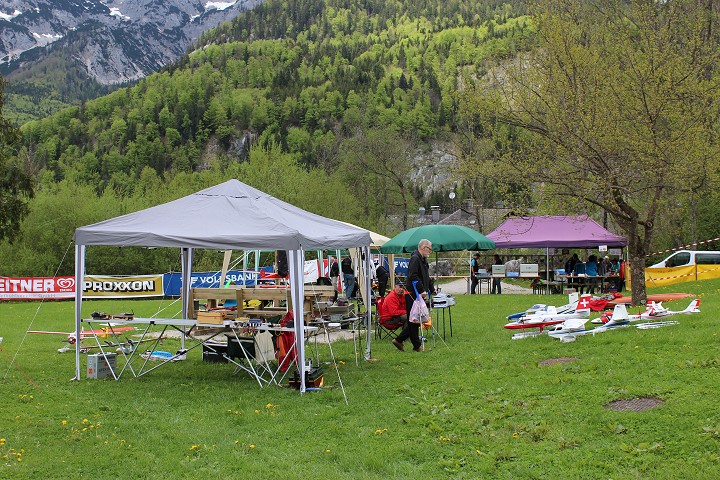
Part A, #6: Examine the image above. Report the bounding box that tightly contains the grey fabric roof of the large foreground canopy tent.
[74,179,371,250]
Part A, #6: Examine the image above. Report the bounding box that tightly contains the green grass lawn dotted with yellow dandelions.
[0,281,720,479]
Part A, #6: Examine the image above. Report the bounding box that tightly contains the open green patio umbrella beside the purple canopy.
[380,224,495,253]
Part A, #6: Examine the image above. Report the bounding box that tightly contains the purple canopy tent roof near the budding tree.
[487,215,627,281]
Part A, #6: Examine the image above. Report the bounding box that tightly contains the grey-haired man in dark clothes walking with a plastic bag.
[392,238,432,352]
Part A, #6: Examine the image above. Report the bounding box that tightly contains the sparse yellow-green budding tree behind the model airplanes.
[475,0,720,304]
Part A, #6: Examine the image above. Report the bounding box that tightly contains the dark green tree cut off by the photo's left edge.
[0,78,33,244]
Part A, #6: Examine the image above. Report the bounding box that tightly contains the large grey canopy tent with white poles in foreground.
[74,180,371,392]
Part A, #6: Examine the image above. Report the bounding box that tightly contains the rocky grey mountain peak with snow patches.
[0,0,261,85]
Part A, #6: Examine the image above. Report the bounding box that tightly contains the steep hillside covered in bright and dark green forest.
[0,0,532,274]
